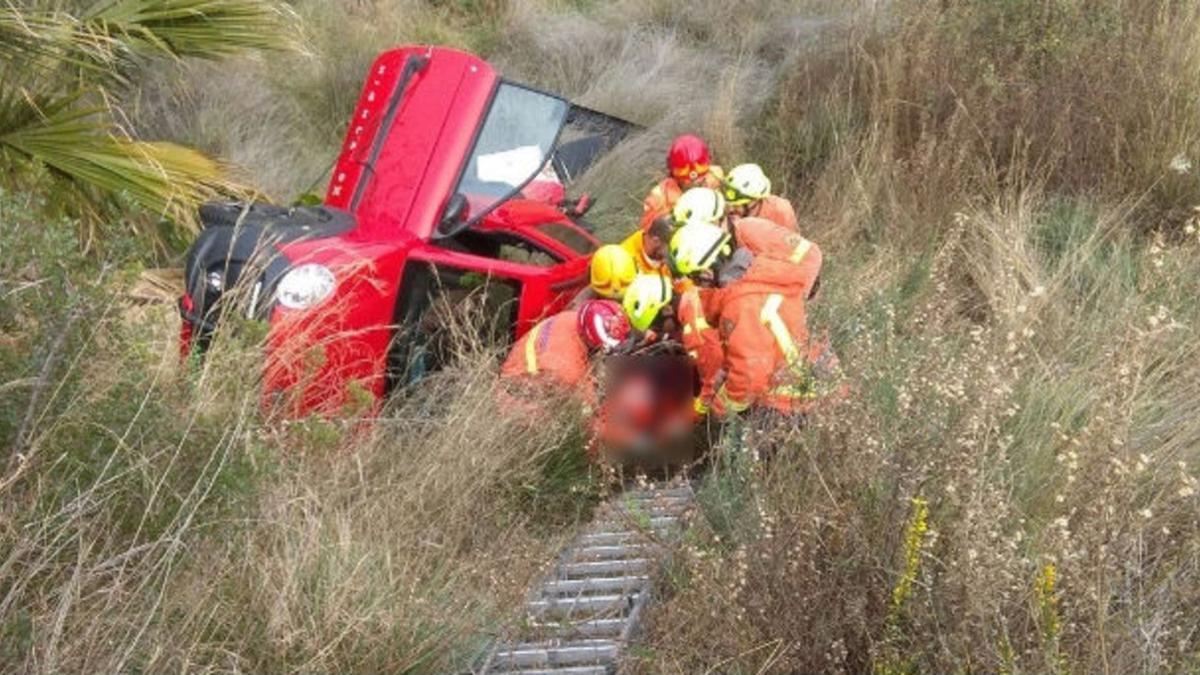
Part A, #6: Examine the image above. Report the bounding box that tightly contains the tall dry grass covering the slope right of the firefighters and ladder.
[640,2,1200,673]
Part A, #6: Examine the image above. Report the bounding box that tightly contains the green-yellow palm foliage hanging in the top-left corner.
[0,0,299,247]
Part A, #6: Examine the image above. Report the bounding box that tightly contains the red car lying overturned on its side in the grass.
[180,47,636,414]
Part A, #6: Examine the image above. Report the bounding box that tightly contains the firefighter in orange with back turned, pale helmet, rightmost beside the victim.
[671,222,818,417]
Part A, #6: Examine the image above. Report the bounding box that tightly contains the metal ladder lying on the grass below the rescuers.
[481,480,695,675]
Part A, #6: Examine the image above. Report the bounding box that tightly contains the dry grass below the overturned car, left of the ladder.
[2,333,592,673]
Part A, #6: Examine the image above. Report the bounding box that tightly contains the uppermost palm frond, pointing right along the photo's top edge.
[82,0,300,59]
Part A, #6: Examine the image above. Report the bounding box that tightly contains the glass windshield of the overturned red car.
[456,82,570,225]
